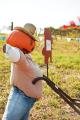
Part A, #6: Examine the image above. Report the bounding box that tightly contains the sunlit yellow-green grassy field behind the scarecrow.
[0,39,80,120]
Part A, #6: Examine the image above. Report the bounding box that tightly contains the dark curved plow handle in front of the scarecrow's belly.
[33,75,80,115]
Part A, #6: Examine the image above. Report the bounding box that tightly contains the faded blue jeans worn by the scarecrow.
[2,86,36,120]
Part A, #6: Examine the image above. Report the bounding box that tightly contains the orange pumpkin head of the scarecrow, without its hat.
[6,30,35,52]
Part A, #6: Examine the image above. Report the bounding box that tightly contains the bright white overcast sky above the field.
[0,0,80,28]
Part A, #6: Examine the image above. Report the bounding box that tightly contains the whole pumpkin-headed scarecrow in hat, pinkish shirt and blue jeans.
[2,23,42,120]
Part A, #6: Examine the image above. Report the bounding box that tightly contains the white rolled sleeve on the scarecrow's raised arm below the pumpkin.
[5,44,20,62]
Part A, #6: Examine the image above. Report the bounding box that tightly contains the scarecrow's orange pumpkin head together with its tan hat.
[7,23,36,53]
